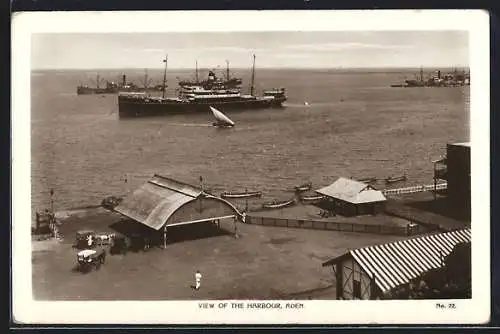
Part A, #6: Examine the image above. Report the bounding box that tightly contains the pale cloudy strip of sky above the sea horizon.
[31,31,469,69]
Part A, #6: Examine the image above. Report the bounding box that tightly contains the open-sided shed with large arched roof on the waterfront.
[114,174,244,244]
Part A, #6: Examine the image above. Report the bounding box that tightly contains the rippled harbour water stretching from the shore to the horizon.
[31,69,469,214]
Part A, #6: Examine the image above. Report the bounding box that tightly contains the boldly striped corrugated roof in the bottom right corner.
[323,228,471,293]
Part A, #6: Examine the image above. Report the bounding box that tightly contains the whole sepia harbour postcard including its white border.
[12,12,490,323]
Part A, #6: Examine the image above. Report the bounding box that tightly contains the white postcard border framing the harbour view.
[11,10,490,324]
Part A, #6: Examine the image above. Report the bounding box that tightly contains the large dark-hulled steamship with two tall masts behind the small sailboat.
[118,55,287,118]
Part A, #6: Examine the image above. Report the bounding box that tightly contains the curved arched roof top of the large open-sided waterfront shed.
[115,175,202,230]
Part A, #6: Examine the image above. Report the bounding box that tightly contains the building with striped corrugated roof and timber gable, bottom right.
[323,228,471,299]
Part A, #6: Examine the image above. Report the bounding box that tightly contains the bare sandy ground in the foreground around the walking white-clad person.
[32,209,408,300]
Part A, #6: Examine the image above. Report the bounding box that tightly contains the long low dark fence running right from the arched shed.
[246,216,428,236]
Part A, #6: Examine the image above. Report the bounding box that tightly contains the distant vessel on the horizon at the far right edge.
[391,68,470,87]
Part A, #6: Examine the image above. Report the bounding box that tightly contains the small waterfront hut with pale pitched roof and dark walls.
[316,177,387,216]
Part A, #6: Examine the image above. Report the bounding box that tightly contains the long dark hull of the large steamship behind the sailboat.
[118,97,283,118]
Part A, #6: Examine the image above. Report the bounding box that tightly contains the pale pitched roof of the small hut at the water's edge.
[316,177,386,204]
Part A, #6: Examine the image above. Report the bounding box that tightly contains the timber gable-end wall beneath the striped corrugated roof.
[336,257,373,300]
